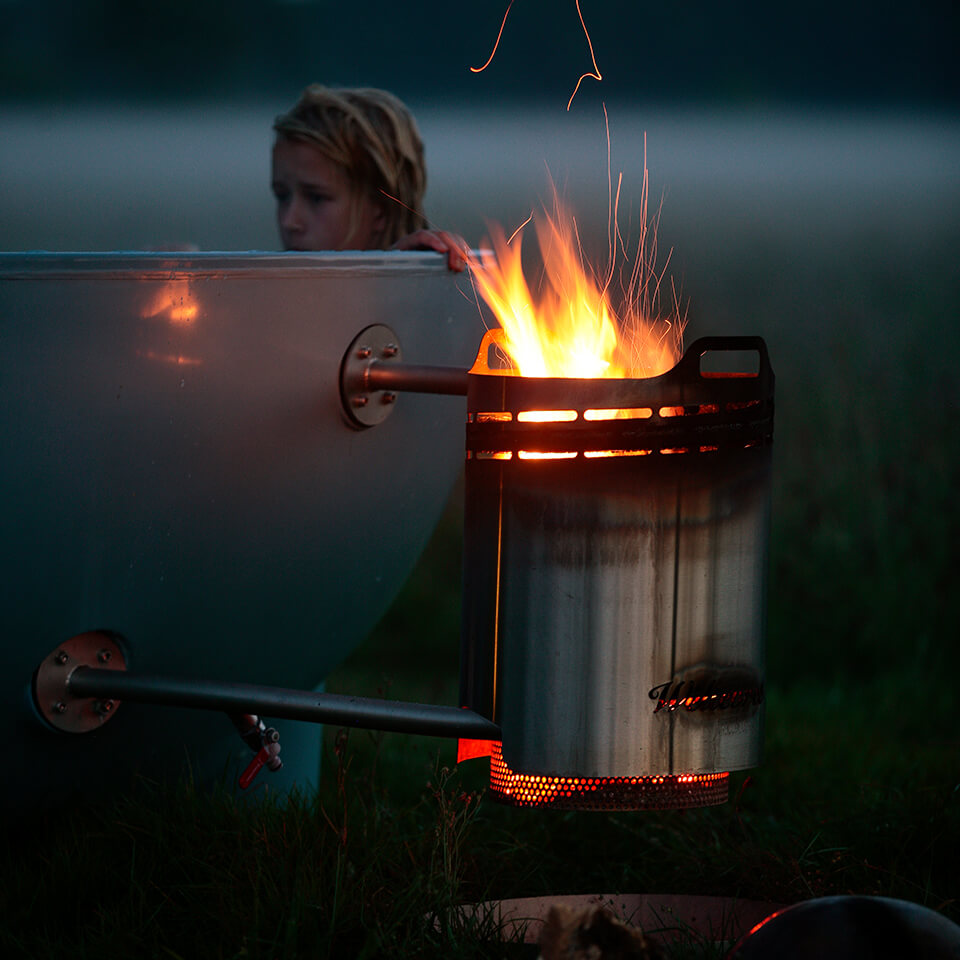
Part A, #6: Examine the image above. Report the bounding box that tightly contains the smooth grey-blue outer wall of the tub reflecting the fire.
[0,253,482,809]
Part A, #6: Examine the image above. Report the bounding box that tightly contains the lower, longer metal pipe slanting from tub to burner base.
[67,667,500,740]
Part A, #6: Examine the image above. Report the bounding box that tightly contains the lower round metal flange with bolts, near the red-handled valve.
[33,630,127,733]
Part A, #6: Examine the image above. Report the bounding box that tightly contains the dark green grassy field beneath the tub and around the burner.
[0,227,960,960]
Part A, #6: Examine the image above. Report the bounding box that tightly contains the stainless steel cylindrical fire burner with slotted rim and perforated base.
[462,338,773,807]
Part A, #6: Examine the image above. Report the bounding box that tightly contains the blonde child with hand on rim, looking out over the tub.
[272,84,467,271]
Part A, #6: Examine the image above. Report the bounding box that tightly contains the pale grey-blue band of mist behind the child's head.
[0,104,960,258]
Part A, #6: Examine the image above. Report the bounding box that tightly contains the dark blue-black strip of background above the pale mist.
[0,0,960,106]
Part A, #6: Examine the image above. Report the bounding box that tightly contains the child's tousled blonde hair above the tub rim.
[273,83,427,247]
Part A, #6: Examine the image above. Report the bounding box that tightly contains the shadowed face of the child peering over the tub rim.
[272,137,385,250]
